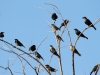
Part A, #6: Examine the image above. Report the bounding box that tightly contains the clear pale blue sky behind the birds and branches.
[0,0,100,75]
